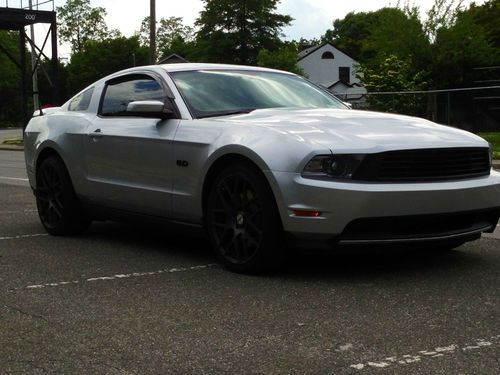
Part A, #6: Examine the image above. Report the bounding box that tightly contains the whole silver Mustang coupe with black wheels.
[25,64,500,272]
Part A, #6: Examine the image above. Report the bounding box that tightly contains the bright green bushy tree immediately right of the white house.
[360,55,426,114]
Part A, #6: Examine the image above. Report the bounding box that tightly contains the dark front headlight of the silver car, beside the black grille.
[302,154,364,180]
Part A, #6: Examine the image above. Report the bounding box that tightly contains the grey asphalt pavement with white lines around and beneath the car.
[0,152,500,375]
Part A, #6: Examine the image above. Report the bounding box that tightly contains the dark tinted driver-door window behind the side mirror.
[101,76,165,116]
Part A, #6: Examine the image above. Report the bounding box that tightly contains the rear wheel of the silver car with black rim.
[35,156,90,235]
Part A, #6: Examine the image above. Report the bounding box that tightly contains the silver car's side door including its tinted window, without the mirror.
[85,73,179,216]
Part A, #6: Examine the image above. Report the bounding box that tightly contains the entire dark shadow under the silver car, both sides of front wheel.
[82,222,485,282]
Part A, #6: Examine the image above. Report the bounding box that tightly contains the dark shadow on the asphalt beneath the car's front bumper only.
[274,242,484,282]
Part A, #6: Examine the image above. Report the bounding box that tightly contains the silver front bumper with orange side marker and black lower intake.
[268,170,500,243]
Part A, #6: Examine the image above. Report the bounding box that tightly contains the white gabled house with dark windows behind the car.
[297,43,366,101]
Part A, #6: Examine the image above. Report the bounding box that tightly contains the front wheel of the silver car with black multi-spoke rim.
[205,163,284,273]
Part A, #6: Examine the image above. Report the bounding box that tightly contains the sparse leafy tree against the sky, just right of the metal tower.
[57,0,110,52]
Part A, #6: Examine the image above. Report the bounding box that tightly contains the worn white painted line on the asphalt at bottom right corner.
[349,335,500,370]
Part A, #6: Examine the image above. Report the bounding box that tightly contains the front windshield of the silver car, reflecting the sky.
[171,70,346,118]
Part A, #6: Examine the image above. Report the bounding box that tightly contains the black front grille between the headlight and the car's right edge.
[353,147,490,182]
